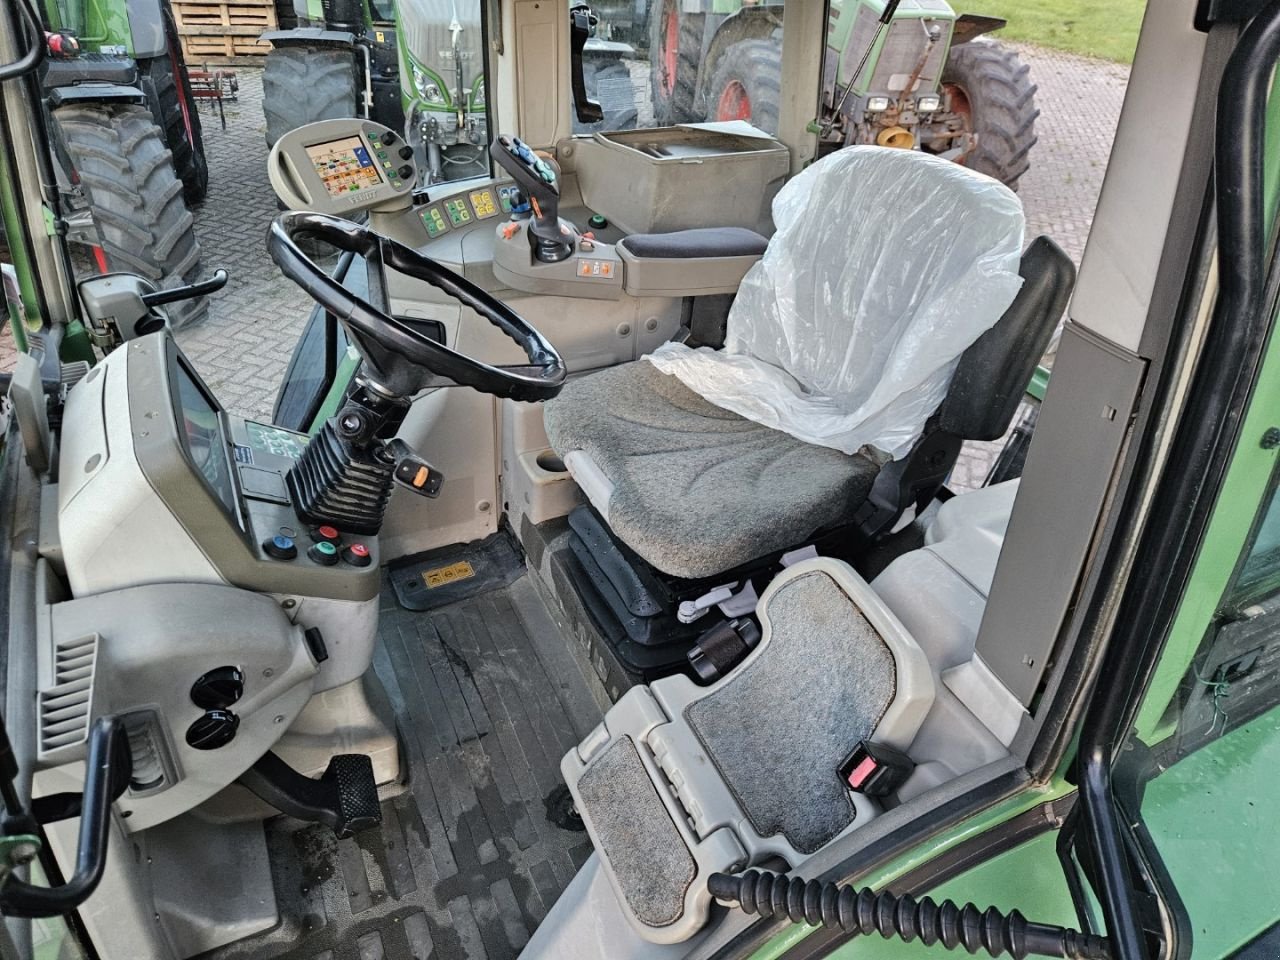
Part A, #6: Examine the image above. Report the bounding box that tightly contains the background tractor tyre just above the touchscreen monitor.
[262,46,358,147]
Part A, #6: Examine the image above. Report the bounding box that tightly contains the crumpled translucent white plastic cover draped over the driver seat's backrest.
[648,146,1024,457]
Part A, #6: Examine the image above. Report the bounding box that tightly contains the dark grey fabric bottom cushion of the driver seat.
[545,360,879,579]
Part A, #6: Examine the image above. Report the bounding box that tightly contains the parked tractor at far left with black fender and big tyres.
[41,0,209,325]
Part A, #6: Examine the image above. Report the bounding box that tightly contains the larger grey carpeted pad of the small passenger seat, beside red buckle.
[685,572,897,854]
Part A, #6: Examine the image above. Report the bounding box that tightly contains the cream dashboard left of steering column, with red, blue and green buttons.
[58,332,378,600]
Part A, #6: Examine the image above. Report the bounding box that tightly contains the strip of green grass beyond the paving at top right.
[952,0,1160,63]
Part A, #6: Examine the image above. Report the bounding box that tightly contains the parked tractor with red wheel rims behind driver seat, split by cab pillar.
[649,0,1039,189]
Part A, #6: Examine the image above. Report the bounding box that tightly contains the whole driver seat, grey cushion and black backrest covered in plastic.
[545,147,1074,581]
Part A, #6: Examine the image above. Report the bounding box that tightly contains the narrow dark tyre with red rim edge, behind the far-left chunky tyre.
[138,5,209,204]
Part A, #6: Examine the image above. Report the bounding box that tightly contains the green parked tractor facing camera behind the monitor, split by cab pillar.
[262,0,636,183]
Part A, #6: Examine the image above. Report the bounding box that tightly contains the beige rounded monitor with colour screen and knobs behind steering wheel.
[266,116,417,216]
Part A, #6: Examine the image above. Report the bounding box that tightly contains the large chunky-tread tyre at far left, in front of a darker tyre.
[52,102,209,328]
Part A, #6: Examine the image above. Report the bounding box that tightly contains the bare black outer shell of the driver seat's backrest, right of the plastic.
[938,237,1075,440]
